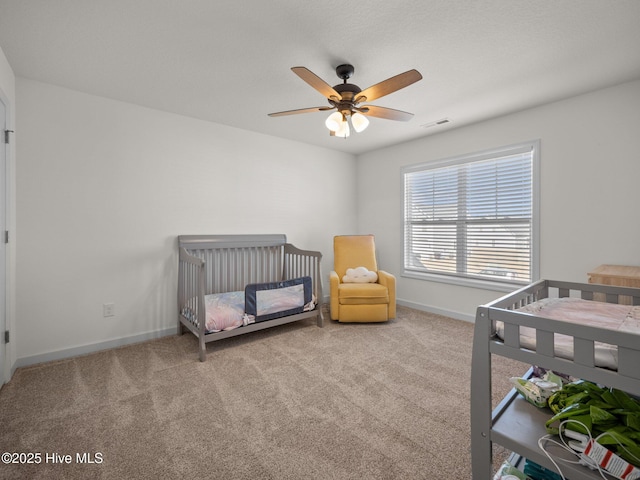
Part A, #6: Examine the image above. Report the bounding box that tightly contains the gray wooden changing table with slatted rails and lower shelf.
[471,280,640,480]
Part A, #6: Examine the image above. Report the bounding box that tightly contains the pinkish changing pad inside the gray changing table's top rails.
[495,297,640,370]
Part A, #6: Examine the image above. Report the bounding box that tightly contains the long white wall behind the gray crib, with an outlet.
[16,78,356,365]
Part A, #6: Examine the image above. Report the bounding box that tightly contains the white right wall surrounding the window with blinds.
[357,81,640,319]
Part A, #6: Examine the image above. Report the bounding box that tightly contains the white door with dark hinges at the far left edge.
[0,97,9,387]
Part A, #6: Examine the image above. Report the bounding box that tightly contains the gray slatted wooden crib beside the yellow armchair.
[178,234,324,362]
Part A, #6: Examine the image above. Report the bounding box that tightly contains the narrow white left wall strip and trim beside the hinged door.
[0,49,16,384]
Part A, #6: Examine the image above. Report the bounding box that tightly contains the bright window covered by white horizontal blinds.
[402,141,539,286]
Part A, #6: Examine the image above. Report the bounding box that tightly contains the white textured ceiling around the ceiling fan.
[0,0,640,154]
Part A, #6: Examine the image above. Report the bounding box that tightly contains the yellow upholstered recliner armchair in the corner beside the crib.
[329,235,396,322]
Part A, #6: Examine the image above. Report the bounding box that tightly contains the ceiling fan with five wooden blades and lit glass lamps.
[269,64,422,138]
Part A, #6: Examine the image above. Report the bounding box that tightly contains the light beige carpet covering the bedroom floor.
[0,308,523,480]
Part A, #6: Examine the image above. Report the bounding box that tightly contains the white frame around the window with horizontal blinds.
[400,140,540,292]
